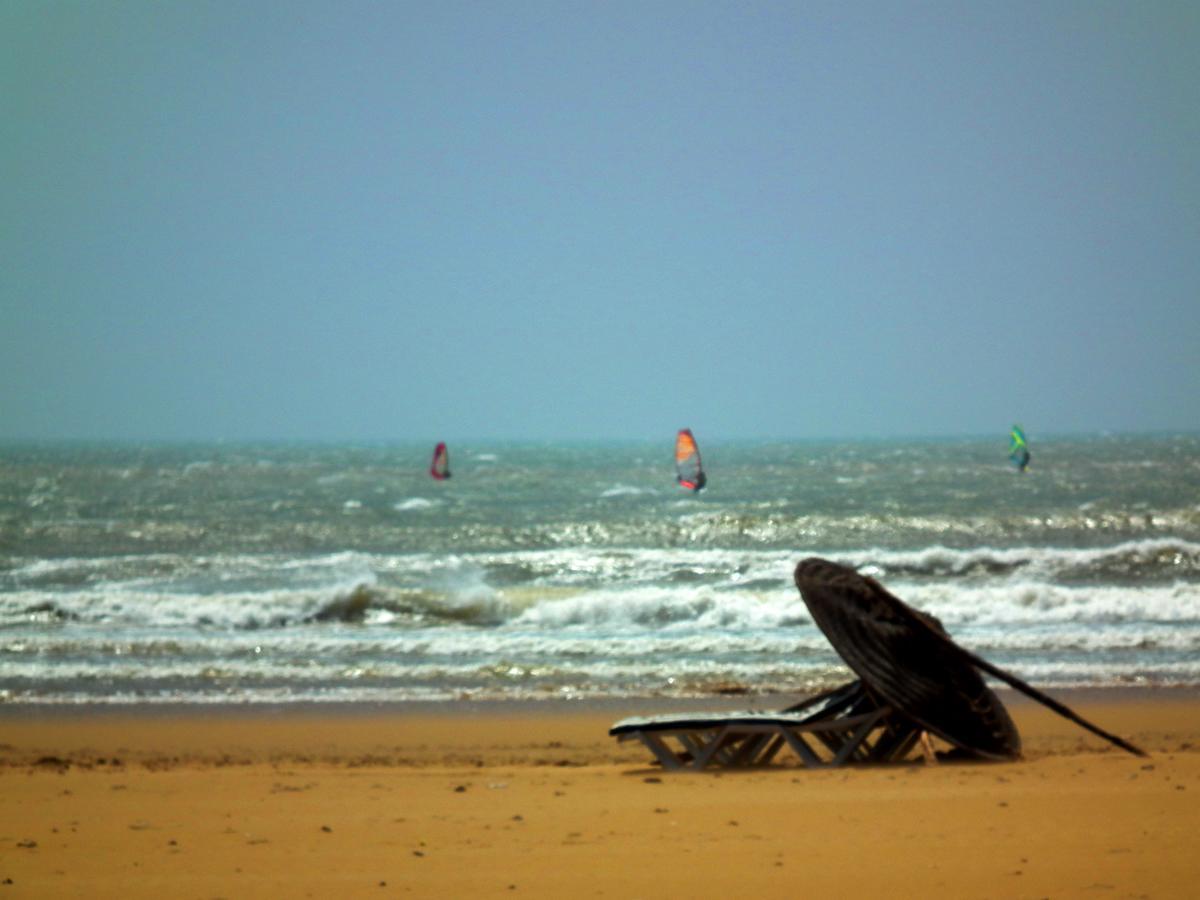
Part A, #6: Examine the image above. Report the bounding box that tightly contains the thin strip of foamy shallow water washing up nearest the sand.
[0,643,1200,708]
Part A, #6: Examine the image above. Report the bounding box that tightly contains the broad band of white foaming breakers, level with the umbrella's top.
[0,541,1200,628]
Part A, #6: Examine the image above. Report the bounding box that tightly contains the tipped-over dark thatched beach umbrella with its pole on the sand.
[796,557,1146,760]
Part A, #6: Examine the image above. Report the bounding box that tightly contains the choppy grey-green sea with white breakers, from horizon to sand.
[0,434,1200,704]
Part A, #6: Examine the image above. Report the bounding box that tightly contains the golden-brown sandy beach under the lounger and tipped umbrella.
[0,691,1200,898]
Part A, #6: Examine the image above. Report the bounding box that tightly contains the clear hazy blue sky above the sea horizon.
[0,0,1200,440]
